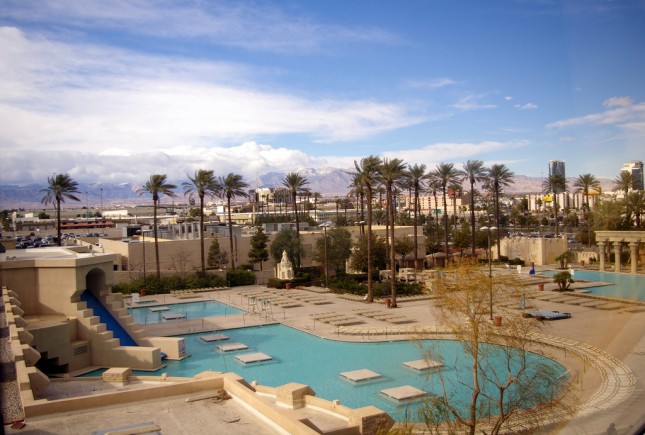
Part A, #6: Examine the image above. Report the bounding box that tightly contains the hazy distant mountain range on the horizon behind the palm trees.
[0,168,613,210]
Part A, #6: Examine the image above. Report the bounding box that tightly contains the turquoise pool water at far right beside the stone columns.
[544,270,645,301]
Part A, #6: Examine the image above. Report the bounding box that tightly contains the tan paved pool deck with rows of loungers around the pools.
[6,270,645,434]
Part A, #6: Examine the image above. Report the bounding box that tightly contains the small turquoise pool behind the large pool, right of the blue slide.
[128,301,244,325]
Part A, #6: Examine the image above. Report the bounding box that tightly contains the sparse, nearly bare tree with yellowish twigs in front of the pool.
[421,264,575,434]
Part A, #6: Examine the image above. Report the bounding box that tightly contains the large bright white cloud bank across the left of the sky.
[0,27,423,155]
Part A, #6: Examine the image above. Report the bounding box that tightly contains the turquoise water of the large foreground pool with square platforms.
[135,325,566,421]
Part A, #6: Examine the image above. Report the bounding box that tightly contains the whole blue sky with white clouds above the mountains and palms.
[0,0,645,184]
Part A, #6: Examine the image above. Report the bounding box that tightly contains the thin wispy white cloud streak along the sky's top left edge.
[0,0,402,54]
